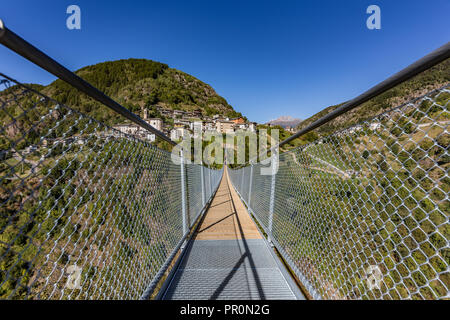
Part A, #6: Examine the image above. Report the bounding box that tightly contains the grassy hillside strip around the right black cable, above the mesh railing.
[297,59,450,135]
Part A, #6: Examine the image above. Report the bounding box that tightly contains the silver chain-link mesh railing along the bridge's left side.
[0,76,222,299]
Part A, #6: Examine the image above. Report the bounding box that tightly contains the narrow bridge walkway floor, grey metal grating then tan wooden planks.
[163,170,304,300]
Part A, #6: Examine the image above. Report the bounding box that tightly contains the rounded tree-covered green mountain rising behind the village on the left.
[26,59,242,124]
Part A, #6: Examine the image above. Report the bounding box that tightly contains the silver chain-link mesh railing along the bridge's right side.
[229,86,450,299]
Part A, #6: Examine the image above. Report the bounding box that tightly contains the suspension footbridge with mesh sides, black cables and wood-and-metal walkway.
[0,22,450,300]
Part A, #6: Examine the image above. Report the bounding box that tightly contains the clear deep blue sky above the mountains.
[0,0,450,122]
